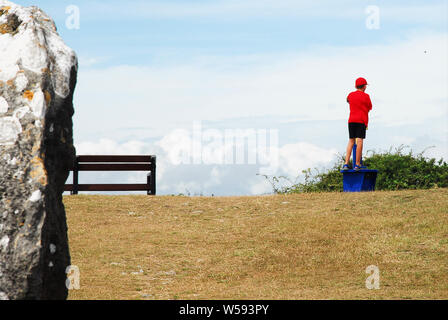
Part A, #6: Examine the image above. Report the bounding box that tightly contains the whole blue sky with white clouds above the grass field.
[17,0,448,195]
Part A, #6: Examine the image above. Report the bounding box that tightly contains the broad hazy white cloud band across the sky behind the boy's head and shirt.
[75,34,448,143]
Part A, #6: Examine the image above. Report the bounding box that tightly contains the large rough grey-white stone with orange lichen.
[0,0,78,300]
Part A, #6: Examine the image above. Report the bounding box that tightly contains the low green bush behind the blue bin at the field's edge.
[264,146,448,194]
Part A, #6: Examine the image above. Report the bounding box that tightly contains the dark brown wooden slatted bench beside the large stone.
[64,156,156,195]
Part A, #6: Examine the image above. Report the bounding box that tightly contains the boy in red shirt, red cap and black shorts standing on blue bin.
[342,78,372,171]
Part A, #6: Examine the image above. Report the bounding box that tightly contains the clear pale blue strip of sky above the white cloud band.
[18,0,447,66]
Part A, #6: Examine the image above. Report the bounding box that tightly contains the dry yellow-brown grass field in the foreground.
[64,189,448,300]
